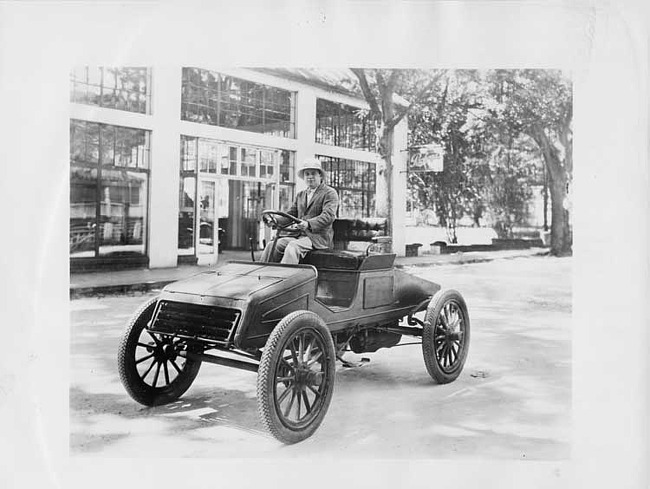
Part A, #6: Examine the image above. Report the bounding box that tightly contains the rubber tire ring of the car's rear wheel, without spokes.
[422,289,470,384]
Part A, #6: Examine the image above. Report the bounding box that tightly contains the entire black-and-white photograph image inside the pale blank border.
[70,66,572,454]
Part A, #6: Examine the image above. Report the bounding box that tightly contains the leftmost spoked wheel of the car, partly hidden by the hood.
[117,297,201,406]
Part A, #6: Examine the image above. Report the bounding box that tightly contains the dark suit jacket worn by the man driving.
[288,183,339,250]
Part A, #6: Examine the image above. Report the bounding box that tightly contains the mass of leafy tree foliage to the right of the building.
[409,70,572,254]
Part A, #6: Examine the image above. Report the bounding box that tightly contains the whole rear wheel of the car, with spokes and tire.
[422,289,470,384]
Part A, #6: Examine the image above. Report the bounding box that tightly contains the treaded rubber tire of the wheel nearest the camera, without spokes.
[257,311,336,445]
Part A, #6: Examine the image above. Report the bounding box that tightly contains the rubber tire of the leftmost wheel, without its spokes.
[117,297,201,406]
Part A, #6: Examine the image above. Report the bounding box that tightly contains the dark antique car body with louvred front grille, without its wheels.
[150,254,440,351]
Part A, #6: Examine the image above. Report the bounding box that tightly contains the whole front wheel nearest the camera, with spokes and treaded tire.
[257,311,336,444]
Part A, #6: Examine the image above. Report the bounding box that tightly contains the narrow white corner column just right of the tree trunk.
[389,117,408,256]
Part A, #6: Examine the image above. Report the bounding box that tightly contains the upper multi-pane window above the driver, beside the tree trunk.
[316,99,377,151]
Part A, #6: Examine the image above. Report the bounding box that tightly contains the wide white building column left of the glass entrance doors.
[149,66,182,268]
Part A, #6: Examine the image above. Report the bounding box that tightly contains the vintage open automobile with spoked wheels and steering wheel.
[118,211,470,444]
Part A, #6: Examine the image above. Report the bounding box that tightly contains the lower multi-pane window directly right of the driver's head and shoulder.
[319,156,377,218]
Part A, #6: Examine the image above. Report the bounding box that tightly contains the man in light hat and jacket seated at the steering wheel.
[261,158,339,264]
